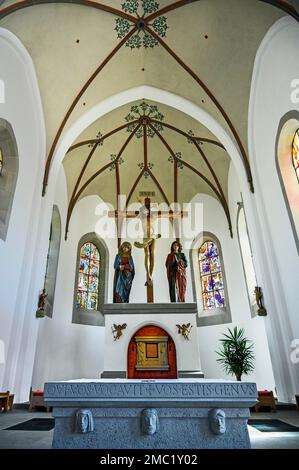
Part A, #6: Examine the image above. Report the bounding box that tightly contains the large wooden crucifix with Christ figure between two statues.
[108,193,188,303]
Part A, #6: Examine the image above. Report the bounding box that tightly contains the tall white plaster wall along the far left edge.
[0,28,45,401]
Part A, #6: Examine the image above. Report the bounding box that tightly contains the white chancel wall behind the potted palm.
[193,188,275,390]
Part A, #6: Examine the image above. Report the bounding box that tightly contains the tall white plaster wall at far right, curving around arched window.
[249,17,299,401]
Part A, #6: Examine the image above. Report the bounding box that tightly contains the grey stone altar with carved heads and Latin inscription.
[45,379,257,449]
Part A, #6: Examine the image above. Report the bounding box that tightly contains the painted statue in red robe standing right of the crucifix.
[165,241,188,302]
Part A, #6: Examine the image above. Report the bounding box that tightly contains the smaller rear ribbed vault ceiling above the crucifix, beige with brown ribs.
[64,100,230,235]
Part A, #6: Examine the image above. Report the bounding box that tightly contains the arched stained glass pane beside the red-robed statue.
[198,240,225,310]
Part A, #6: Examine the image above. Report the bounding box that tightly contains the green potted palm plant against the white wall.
[216,327,254,381]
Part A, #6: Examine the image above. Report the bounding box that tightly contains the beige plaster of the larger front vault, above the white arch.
[0,0,290,191]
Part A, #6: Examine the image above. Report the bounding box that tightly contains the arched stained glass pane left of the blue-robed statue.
[77,242,100,310]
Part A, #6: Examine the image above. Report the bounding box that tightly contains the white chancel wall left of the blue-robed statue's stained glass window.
[32,174,104,389]
